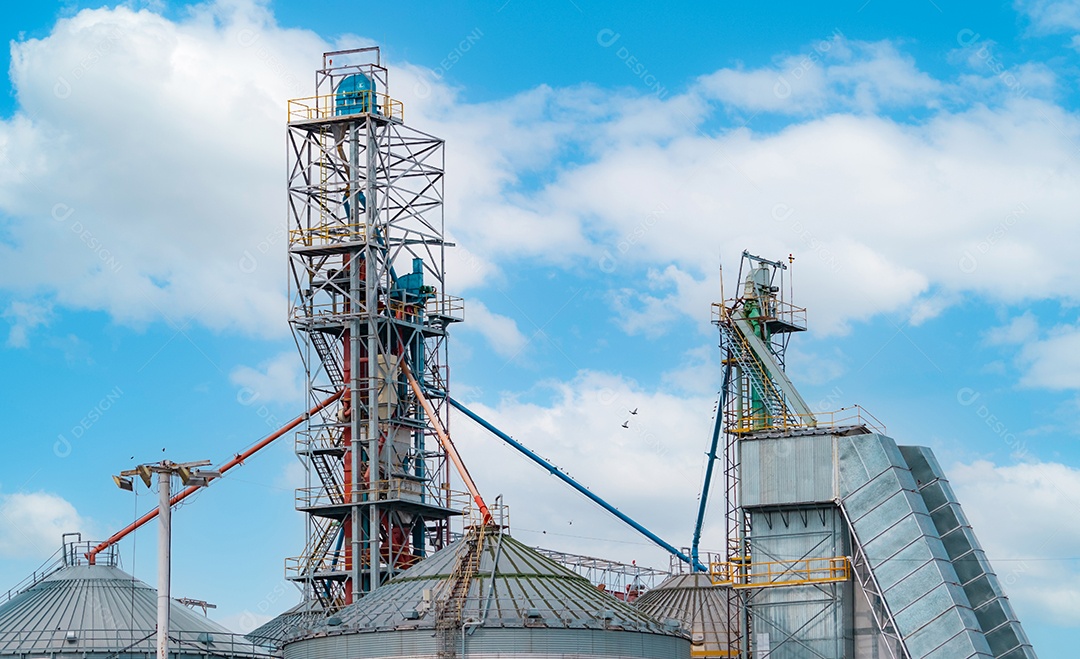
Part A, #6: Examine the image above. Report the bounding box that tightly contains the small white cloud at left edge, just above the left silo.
[0,492,90,559]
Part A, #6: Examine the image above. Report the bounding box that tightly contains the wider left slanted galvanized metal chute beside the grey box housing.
[833,434,993,658]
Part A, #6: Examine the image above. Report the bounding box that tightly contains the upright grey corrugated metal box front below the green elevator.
[740,434,837,508]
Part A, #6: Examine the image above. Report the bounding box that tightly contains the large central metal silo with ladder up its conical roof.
[284,526,690,659]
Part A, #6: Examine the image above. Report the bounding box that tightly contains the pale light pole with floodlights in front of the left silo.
[112,460,221,659]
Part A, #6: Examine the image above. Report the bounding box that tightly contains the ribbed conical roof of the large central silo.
[291,534,681,635]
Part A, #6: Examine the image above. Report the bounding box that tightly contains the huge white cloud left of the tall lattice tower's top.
[0,2,324,335]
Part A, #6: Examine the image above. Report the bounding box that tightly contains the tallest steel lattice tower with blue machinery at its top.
[286,48,462,609]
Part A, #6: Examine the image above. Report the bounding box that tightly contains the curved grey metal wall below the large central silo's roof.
[285,627,690,659]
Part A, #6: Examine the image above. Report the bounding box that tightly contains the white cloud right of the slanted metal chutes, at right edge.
[948,461,1080,627]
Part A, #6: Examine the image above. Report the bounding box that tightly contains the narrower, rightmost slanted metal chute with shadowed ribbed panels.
[900,446,1036,659]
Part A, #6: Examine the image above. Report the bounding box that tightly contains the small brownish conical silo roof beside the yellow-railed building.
[634,573,734,657]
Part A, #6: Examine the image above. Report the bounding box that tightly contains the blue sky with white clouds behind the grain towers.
[0,0,1080,657]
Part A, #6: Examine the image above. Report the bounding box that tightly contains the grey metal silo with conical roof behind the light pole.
[0,539,269,659]
